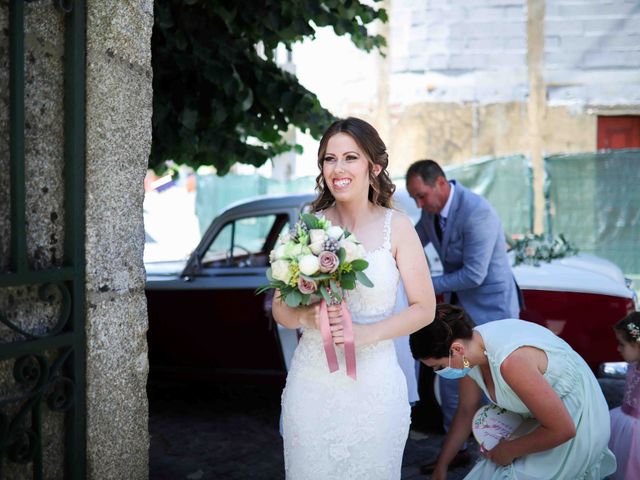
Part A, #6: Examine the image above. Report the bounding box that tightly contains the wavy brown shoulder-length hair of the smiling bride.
[312,117,396,212]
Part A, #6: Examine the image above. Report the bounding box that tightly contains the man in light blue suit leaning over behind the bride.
[406,160,520,473]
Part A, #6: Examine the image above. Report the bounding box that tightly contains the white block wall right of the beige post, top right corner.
[544,0,640,106]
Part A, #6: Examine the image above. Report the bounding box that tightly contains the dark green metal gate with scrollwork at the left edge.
[0,0,86,479]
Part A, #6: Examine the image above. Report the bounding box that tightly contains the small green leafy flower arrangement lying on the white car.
[510,234,578,267]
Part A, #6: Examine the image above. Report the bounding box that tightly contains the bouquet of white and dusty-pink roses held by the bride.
[257,213,373,308]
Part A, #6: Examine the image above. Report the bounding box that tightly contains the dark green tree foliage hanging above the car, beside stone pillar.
[149,0,387,175]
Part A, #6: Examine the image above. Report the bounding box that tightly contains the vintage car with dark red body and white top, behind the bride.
[145,190,637,382]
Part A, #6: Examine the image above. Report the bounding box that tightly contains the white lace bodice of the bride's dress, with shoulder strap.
[345,208,400,323]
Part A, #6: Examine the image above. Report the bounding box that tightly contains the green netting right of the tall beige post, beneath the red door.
[545,149,640,276]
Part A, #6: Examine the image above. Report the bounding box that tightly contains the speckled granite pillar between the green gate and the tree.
[86,0,153,480]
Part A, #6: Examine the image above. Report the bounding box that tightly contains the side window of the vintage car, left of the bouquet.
[202,214,288,266]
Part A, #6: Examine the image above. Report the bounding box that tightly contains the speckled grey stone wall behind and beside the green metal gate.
[0,0,153,480]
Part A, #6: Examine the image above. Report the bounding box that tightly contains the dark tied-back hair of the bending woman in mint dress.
[409,303,475,360]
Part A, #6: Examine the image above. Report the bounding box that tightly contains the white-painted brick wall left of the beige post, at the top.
[390,0,527,105]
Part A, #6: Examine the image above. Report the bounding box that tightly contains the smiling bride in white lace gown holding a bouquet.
[273,118,435,480]
